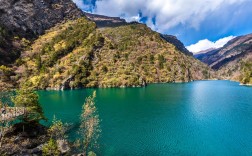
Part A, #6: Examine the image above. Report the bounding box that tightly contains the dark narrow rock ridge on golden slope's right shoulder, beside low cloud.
[161,34,193,56]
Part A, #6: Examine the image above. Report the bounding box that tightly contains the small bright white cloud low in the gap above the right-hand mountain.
[186,36,235,53]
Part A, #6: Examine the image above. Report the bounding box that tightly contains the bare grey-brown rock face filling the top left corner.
[0,0,83,38]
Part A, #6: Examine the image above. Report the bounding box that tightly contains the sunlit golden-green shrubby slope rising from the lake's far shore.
[13,18,214,90]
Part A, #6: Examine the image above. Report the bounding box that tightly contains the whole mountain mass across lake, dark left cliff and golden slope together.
[0,0,214,90]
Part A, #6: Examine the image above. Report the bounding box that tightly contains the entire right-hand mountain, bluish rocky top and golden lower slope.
[195,34,252,84]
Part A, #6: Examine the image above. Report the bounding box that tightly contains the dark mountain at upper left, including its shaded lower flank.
[0,0,83,65]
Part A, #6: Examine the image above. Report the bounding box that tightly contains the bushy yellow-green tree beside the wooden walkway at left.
[12,85,46,124]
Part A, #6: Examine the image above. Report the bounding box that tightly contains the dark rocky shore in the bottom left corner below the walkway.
[0,124,49,156]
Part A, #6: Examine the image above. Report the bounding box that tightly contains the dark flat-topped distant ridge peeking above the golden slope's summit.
[85,13,128,28]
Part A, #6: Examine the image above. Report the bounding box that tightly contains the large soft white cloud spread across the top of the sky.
[87,0,246,32]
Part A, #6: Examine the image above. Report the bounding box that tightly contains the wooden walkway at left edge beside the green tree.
[0,107,26,122]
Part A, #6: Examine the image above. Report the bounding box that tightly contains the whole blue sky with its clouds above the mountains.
[73,0,252,52]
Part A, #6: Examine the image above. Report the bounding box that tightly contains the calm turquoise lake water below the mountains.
[39,81,252,156]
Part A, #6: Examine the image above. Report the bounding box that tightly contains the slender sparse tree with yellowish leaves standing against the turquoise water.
[80,91,101,156]
